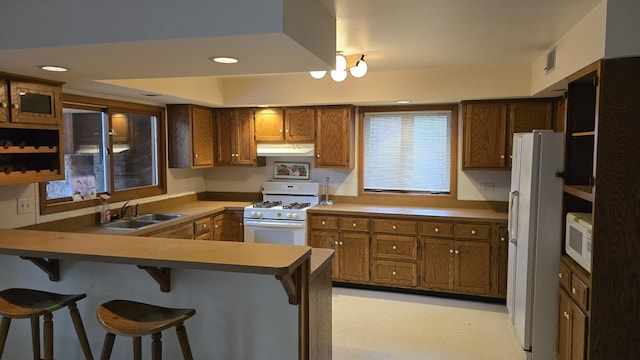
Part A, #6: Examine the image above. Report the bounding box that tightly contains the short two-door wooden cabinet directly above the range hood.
[255,108,316,142]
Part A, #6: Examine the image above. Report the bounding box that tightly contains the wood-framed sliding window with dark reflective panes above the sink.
[40,95,166,214]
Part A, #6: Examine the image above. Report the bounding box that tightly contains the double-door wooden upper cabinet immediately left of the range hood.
[215,109,266,166]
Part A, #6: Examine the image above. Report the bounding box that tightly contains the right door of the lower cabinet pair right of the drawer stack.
[454,241,491,294]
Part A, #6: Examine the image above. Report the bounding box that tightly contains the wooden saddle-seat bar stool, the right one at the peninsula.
[97,300,196,360]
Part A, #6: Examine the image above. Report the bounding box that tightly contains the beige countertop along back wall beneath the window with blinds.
[309,203,508,222]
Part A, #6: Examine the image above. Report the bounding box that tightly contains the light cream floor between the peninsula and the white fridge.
[333,287,523,360]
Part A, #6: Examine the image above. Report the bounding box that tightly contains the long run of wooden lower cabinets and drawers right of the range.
[309,213,508,298]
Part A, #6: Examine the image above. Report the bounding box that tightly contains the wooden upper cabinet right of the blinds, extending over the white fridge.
[462,99,555,170]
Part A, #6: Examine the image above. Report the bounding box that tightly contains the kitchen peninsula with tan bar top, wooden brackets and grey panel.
[0,230,333,359]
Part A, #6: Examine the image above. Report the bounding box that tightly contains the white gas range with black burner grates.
[244,181,320,245]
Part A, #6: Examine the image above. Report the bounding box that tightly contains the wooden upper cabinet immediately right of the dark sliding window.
[167,105,213,169]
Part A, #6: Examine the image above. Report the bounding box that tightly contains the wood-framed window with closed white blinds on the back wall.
[359,104,458,198]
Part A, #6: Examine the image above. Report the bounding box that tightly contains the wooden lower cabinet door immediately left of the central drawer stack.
[340,233,369,282]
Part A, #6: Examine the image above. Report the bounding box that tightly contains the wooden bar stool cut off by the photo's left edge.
[0,288,93,360]
